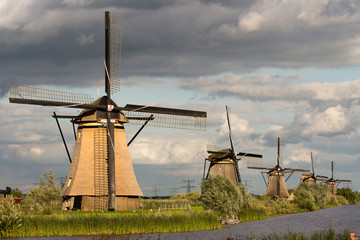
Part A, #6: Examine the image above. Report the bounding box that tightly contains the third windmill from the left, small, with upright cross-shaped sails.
[248,138,310,198]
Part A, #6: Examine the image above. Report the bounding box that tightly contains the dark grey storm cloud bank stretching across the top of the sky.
[0,0,360,95]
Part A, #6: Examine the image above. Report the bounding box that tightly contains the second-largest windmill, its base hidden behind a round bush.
[203,106,262,184]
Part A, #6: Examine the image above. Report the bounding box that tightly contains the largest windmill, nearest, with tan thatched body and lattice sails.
[9,12,206,211]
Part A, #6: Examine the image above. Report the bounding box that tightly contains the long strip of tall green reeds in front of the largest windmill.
[7,212,221,237]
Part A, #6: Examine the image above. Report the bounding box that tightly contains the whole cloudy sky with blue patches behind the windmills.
[0,0,360,196]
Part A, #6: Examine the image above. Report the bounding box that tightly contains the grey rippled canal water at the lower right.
[14,204,360,240]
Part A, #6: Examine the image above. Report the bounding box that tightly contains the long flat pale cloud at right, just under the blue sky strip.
[179,75,360,104]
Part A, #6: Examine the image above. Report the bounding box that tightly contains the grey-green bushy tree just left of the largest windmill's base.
[24,169,61,211]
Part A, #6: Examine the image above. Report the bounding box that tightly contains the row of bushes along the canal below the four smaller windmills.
[199,176,360,218]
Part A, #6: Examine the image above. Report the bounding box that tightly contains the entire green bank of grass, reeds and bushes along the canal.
[0,170,360,239]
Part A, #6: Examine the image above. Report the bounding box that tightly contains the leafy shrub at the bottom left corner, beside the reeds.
[0,195,22,237]
